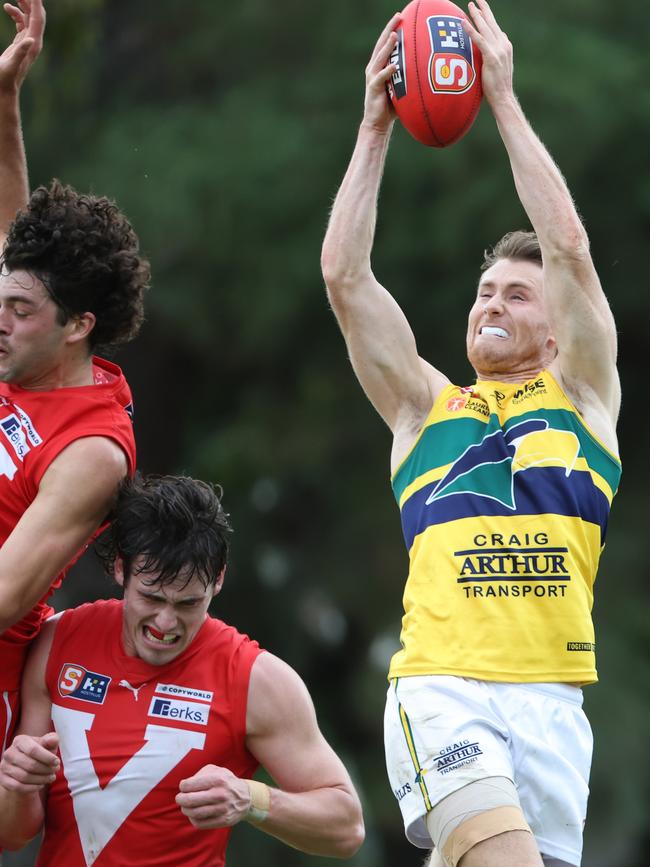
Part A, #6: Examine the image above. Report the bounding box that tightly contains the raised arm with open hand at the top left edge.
[0,0,45,248]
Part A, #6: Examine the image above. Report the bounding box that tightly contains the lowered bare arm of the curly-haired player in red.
[0,437,127,631]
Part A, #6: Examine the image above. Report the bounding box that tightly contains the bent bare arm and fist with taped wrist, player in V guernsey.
[176,653,364,858]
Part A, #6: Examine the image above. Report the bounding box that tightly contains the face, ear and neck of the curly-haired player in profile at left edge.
[0,269,95,389]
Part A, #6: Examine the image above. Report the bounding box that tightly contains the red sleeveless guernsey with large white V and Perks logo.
[37,600,261,867]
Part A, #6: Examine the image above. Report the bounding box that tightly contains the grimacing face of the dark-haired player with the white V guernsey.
[115,558,225,665]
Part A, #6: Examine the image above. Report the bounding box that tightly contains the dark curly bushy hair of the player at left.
[2,180,150,349]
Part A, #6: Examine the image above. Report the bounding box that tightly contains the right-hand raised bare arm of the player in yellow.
[467,0,620,447]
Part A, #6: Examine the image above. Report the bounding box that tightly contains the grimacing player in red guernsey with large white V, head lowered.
[0,476,364,867]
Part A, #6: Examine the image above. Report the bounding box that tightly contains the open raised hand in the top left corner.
[0,0,45,93]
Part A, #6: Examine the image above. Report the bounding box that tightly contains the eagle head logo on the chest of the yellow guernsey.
[425,418,580,511]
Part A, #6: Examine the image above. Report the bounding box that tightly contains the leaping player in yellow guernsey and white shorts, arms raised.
[322,0,620,867]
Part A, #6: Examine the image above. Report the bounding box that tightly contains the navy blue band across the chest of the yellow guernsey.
[402,464,609,550]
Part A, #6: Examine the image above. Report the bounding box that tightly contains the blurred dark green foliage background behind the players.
[0,0,650,867]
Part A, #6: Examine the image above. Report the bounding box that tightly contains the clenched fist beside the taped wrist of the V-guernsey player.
[176,765,251,829]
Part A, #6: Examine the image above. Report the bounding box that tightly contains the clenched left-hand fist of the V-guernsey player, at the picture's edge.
[0,732,60,794]
